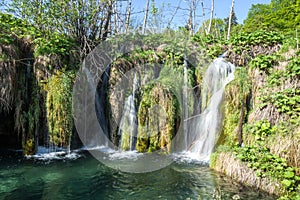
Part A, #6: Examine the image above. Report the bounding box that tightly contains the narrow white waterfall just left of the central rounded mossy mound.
[118,73,138,151]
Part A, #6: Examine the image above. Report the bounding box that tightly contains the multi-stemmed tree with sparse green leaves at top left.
[2,0,116,58]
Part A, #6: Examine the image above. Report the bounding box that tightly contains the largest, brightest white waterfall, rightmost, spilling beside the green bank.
[187,58,235,161]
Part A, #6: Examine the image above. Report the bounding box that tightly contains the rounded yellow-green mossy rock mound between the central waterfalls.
[136,83,179,152]
